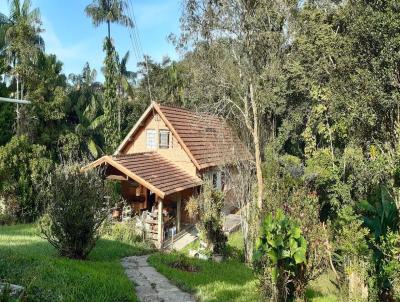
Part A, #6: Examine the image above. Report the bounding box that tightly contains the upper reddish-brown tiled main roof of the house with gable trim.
[116,102,252,170]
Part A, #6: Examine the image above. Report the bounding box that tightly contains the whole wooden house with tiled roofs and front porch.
[83,102,251,247]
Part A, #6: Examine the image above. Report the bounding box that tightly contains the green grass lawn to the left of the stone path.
[0,225,152,302]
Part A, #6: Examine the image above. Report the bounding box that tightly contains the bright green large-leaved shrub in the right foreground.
[254,209,307,301]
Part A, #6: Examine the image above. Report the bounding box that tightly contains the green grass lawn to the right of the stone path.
[149,232,339,302]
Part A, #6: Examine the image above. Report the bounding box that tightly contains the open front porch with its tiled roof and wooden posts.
[83,152,202,248]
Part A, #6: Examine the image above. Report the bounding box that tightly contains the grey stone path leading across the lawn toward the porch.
[121,255,196,302]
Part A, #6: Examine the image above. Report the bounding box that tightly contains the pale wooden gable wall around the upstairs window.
[122,113,197,176]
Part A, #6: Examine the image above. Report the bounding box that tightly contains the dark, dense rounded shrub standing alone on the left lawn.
[39,165,115,259]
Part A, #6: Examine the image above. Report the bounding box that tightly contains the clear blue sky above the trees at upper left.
[0,0,181,80]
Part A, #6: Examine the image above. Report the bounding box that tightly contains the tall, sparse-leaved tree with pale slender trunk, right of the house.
[182,0,297,209]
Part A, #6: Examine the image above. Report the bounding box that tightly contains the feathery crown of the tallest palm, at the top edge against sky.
[85,0,133,40]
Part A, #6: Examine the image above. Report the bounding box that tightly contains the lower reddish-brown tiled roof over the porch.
[82,152,202,198]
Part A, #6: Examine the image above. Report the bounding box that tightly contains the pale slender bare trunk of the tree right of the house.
[250,84,264,210]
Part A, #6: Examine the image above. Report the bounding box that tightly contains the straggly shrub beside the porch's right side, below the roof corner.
[186,182,228,254]
